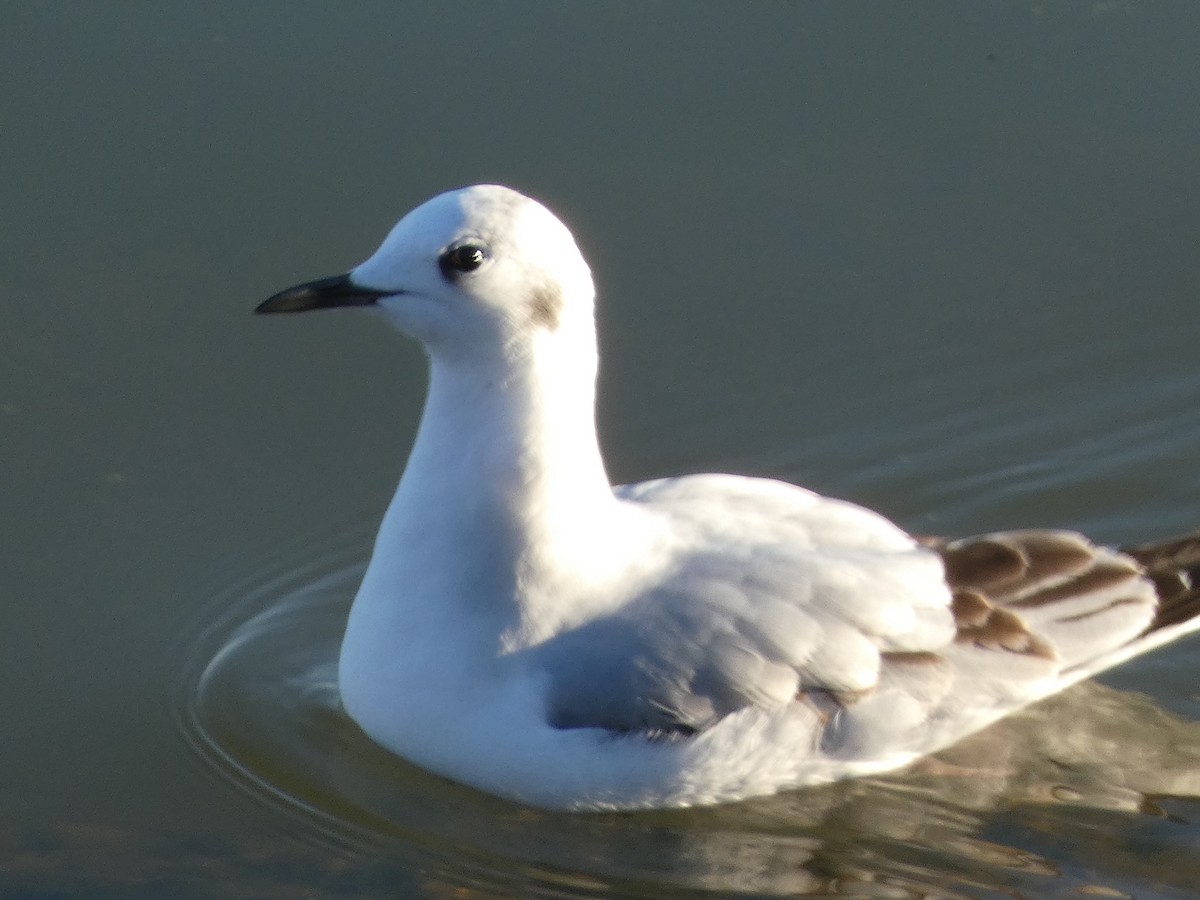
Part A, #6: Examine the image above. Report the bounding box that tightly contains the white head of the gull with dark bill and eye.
[257,185,593,354]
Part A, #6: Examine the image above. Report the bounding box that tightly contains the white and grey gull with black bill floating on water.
[257,185,1200,810]
